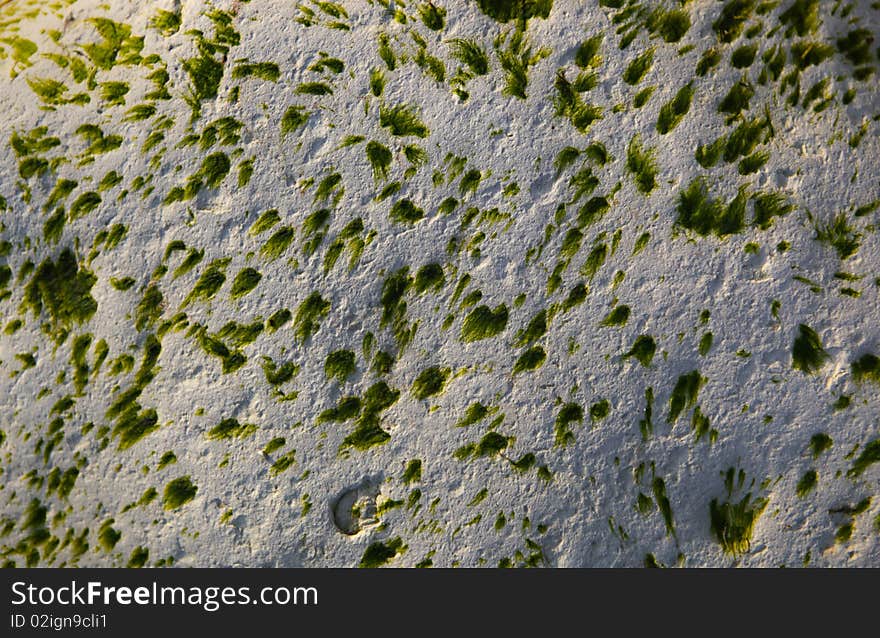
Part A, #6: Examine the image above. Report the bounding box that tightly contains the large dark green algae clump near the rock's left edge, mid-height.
[22,248,98,343]
